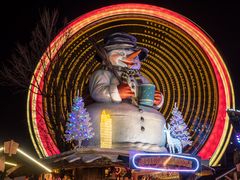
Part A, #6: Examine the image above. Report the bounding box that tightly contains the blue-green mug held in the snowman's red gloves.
[138,84,155,106]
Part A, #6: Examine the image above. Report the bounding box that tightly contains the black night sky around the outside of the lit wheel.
[0,0,240,157]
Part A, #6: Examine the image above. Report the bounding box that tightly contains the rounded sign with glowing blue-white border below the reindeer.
[130,153,200,172]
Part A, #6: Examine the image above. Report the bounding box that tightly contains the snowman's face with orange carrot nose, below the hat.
[108,49,141,70]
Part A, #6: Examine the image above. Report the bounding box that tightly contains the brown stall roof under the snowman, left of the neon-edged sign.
[44,148,129,169]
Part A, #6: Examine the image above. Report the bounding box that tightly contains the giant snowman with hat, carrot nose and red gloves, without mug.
[87,32,165,150]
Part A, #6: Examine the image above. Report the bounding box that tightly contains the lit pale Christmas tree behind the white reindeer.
[170,103,192,147]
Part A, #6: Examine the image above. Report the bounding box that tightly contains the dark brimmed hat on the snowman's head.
[96,32,149,62]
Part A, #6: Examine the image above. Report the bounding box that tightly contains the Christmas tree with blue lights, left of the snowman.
[65,96,94,147]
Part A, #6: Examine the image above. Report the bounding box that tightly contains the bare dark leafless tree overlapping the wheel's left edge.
[0,9,71,154]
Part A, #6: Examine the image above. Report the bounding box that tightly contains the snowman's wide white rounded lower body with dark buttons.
[87,103,166,147]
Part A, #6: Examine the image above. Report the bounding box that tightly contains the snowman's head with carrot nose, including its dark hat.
[96,32,148,69]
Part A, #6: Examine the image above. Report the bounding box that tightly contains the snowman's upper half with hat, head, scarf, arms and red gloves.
[89,32,164,109]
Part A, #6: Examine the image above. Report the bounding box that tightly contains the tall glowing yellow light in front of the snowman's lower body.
[100,110,112,148]
